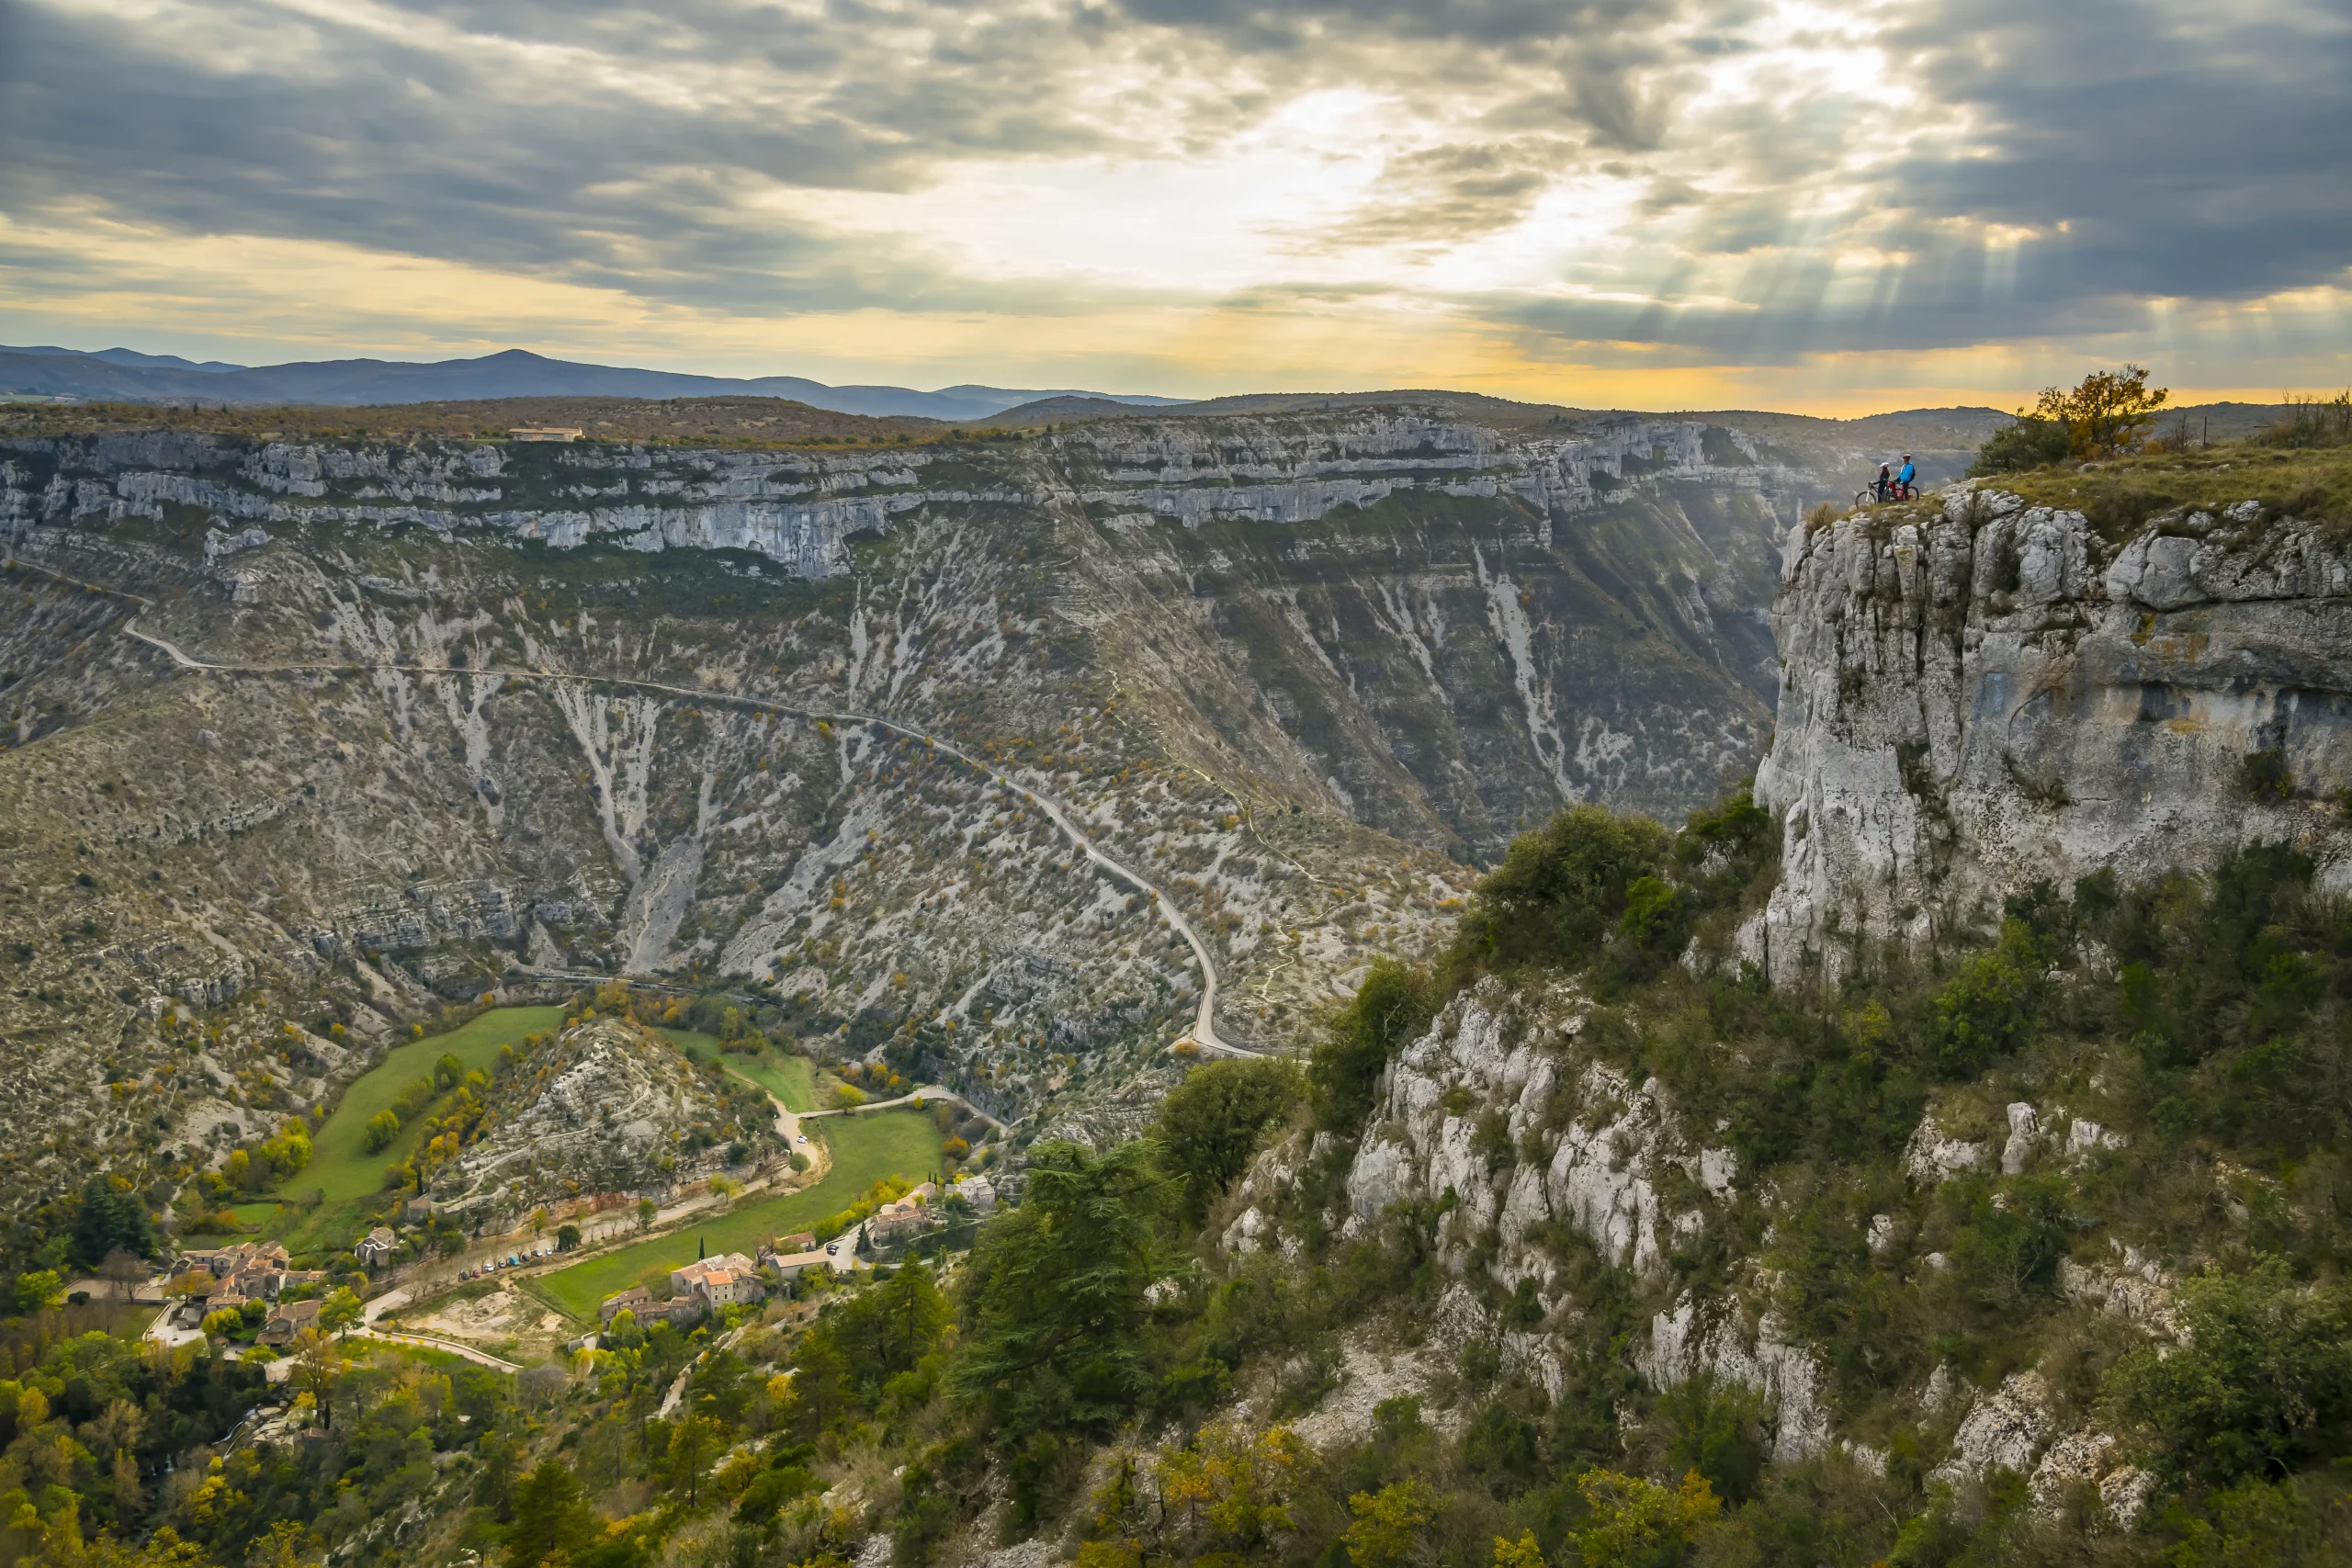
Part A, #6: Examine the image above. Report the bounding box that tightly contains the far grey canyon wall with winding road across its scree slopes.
[0,407,1947,1194]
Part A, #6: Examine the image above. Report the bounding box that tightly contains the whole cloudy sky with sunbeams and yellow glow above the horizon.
[0,0,2352,412]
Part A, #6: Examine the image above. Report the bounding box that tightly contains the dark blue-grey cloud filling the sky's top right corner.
[1886,0,2352,308]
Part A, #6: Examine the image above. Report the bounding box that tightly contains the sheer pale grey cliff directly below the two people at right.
[1743,489,2352,983]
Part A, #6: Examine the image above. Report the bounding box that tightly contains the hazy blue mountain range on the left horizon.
[0,348,1183,423]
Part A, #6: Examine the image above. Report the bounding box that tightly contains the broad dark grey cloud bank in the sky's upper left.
[0,3,1128,312]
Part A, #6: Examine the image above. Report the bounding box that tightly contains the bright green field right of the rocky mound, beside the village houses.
[532,1110,938,1324]
